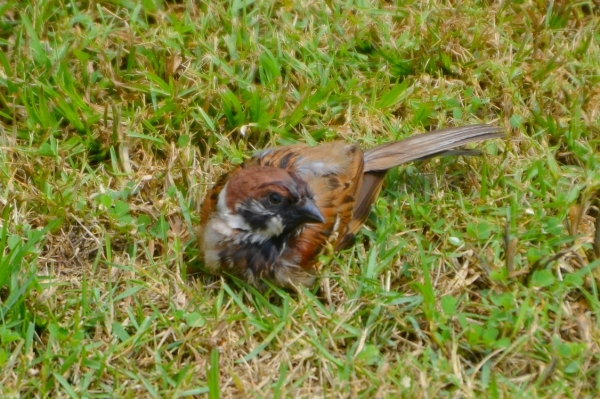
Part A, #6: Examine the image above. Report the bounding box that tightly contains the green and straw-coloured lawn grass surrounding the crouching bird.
[0,0,600,398]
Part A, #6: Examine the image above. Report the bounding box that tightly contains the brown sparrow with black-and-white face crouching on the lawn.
[198,125,502,289]
